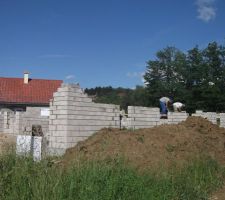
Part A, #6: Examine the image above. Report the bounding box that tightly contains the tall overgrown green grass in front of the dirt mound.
[0,154,224,200]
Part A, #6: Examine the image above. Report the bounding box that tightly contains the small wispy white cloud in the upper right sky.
[196,0,216,22]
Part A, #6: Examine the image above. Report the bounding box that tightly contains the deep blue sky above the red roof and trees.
[0,0,225,88]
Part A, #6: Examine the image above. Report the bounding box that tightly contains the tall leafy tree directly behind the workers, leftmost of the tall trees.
[144,47,186,105]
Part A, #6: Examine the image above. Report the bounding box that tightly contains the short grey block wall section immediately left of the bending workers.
[128,106,161,129]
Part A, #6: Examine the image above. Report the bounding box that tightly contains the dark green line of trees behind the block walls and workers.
[85,42,225,112]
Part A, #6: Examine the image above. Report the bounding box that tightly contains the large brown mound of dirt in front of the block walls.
[63,117,225,169]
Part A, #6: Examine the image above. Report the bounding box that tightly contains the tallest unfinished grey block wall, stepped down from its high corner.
[48,84,120,154]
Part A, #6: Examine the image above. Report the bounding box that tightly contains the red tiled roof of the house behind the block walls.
[0,77,62,104]
